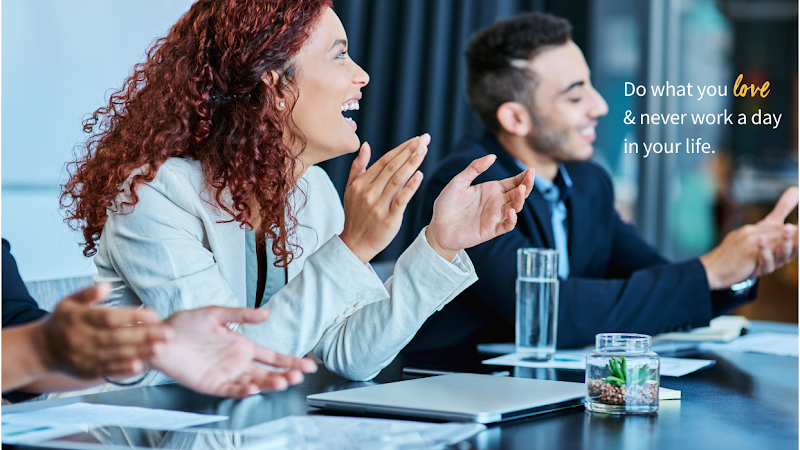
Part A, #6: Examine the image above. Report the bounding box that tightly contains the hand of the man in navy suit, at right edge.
[700,187,798,289]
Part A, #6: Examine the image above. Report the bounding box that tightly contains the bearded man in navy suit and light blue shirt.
[406,13,798,351]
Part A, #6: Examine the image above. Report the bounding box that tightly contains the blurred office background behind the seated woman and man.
[0,0,798,322]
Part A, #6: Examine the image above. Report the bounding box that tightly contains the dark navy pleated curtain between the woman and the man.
[321,0,589,261]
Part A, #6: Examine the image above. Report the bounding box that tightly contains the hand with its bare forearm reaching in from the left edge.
[3,284,170,392]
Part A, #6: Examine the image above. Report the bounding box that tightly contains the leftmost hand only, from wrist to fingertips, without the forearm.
[38,284,170,379]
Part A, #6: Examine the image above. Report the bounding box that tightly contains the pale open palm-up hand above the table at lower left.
[150,306,317,397]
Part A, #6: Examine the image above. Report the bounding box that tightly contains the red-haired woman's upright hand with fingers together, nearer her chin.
[339,134,431,263]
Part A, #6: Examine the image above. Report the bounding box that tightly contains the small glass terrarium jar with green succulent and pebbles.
[585,333,660,414]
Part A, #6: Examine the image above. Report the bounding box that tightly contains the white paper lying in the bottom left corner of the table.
[3,403,228,443]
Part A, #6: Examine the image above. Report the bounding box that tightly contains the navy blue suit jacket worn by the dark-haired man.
[406,134,755,351]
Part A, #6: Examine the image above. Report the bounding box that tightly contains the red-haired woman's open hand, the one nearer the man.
[426,155,534,261]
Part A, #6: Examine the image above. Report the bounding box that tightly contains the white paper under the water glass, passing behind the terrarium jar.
[483,352,715,377]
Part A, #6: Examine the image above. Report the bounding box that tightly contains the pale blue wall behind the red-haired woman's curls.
[0,0,192,281]
